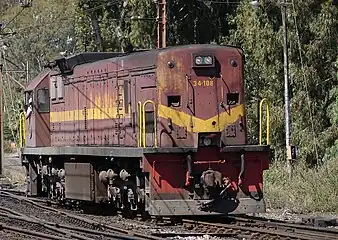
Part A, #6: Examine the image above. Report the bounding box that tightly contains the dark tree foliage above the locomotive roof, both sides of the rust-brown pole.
[76,0,235,51]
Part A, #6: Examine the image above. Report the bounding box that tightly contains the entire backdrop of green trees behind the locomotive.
[0,0,338,168]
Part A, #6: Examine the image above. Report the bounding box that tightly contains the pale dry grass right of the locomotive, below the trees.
[264,161,338,213]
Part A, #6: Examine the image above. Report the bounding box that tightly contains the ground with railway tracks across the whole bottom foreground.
[0,155,338,240]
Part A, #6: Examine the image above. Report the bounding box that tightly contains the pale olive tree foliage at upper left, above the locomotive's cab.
[4,0,76,76]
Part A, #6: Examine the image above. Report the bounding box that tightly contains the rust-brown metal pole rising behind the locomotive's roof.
[156,0,167,48]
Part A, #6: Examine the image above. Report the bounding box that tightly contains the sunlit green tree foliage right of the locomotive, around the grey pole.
[227,0,338,163]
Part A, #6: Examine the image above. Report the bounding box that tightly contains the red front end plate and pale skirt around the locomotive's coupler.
[143,148,268,215]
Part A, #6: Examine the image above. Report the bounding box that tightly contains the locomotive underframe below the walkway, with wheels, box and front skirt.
[21,145,269,216]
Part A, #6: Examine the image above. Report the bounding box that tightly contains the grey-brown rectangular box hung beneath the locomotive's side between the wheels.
[65,163,94,201]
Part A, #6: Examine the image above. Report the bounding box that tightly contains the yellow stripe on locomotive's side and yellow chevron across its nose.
[50,104,244,132]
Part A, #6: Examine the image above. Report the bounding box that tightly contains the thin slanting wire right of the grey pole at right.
[292,0,319,163]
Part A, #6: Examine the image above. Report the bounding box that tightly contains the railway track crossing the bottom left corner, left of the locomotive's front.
[0,191,163,240]
